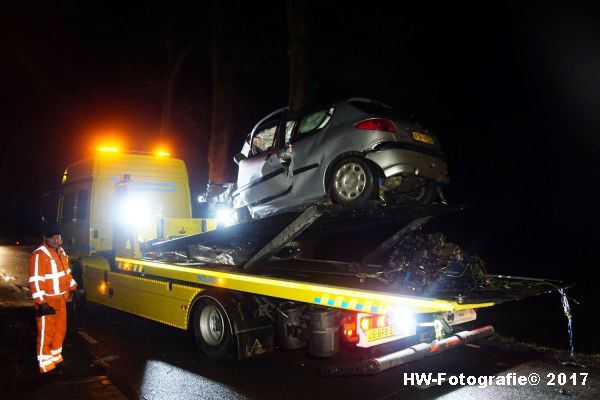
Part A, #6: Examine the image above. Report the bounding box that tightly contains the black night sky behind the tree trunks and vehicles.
[0,1,600,296]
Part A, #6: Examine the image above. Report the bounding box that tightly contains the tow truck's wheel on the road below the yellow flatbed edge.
[194,297,234,359]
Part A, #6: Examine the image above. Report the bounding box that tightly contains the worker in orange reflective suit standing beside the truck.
[29,224,77,373]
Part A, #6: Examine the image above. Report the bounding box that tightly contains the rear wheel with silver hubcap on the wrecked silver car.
[329,157,374,207]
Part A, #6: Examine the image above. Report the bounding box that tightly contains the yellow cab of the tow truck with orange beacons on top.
[44,148,215,257]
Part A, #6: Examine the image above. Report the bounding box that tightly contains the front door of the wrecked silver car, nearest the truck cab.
[234,109,291,206]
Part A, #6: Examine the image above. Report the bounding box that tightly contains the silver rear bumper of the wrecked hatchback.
[365,148,450,185]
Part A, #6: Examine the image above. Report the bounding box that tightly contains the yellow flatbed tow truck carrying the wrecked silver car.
[46,149,562,375]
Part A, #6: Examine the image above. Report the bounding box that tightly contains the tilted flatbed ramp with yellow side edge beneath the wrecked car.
[143,204,561,314]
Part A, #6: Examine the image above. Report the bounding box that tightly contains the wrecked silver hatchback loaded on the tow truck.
[233,98,449,219]
